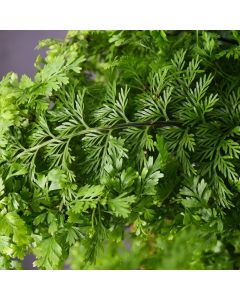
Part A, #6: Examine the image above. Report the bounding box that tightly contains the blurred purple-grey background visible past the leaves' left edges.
[0,30,67,270]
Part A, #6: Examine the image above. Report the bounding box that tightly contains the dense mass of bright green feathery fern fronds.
[0,31,240,269]
